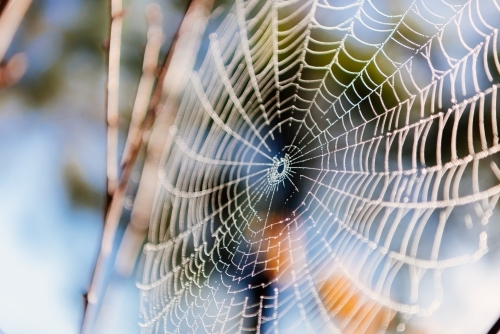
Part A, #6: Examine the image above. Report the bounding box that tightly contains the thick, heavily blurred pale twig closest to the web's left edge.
[116,0,213,276]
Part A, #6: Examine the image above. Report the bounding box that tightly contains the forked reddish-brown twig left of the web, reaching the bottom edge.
[82,0,211,333]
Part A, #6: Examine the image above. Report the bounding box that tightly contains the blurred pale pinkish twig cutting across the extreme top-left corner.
[0,0,31,61]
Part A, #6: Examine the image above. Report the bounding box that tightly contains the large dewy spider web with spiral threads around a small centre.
[138,0,500,333]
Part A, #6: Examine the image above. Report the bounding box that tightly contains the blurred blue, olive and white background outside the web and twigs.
[0,0,500,334]
